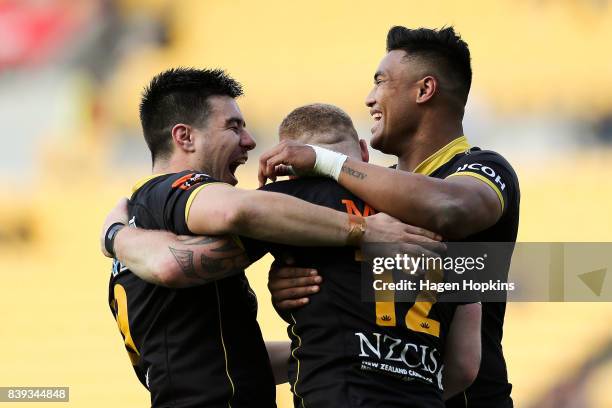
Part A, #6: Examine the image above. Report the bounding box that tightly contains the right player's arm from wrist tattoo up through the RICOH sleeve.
[340,152,518,239]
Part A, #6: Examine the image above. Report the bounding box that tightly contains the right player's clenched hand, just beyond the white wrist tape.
[257,140,317,187]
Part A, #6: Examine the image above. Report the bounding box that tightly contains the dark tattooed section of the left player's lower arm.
[168,237,249,282]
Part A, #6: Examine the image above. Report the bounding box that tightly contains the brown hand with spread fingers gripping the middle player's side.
[268,265,323,310]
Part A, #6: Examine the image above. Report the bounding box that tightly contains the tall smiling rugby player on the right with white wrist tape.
[259,27,520,408]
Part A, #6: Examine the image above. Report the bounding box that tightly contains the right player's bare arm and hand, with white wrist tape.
[259,141,503,239]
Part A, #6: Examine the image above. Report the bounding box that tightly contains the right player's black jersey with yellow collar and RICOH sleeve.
[408,137,520,408]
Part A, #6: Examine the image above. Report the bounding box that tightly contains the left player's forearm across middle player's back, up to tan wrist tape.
[233,191,350,246]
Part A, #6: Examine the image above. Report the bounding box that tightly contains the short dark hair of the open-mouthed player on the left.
[140,67,242,162]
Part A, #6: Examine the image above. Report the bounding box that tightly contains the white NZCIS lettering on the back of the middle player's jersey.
[355,332,444,389]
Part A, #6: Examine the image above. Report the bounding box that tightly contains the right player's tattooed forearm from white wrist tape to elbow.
[338,158,472,238]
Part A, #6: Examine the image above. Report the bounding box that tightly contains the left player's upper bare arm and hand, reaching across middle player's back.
[186,184,440,246]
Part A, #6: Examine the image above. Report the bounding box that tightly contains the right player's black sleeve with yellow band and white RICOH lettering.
[446,151,518,214]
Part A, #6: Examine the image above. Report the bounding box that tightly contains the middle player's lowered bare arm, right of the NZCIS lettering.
[443,303,482,400]
